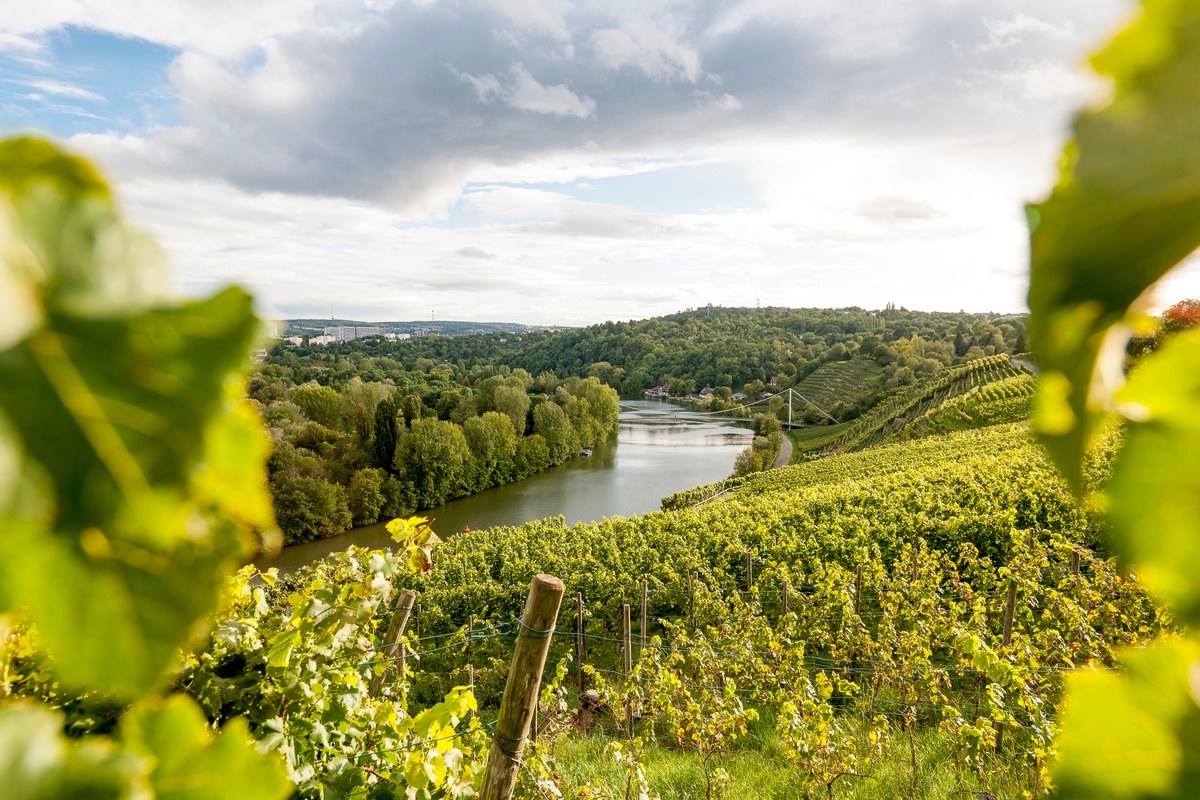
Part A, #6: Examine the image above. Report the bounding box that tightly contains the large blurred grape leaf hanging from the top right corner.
[1028,0,1200,491]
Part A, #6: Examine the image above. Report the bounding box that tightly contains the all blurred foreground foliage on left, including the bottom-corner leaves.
[0,139,288,800]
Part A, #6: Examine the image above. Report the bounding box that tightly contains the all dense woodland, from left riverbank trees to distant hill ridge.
[262,307,1025,542]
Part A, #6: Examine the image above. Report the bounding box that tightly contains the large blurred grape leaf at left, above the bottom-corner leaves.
[0,139,274,697]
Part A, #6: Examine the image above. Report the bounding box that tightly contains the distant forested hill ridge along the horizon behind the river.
[272,307,1026,407]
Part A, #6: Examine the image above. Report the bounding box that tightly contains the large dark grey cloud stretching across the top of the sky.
[39,0,1132,213]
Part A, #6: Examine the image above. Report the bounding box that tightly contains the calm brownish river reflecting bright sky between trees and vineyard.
[256,401,754,571]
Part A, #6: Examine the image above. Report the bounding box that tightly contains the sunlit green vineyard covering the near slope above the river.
[8,425,1156,798]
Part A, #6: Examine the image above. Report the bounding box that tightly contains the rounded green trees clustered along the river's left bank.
[258,353,619,543]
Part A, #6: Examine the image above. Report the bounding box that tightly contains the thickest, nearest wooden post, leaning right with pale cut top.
[479,575,564,800]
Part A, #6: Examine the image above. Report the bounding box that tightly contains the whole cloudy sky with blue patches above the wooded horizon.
[0,0,1200,325]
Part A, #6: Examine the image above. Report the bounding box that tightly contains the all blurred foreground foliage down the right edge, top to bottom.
[1030,0,1200,798]
